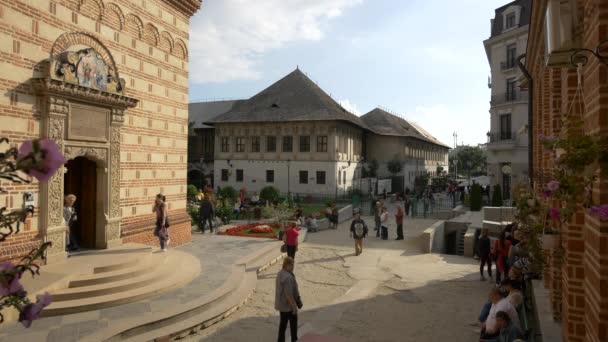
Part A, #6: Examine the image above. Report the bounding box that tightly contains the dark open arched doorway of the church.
[63,157,101,248]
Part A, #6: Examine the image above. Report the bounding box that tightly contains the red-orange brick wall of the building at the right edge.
[527,0,608,342]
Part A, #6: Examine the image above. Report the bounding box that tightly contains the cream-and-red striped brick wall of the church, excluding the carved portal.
[0,0,197,259]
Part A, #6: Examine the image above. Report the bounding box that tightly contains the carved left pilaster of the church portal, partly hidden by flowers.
[40,96,69,263]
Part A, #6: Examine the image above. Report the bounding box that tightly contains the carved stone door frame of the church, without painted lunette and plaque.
[32,32,138,262]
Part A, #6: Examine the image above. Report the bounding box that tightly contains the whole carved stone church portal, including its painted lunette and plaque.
[33,32,138,262]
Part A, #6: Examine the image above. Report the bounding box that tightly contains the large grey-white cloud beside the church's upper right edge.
[190,0,363,83]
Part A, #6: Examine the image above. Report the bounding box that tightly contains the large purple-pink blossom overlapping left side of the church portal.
[18,139,66,182]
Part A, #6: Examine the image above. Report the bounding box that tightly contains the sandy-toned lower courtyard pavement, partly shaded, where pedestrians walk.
[188,208,489,342]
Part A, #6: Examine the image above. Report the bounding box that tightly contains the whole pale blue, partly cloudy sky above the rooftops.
[189,0,508,146]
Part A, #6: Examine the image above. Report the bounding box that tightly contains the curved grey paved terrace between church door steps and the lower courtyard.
[0,233,275,342]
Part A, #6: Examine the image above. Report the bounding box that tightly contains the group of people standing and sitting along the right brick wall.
[475,224,529,342]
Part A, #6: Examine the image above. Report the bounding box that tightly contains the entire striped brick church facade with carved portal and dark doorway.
[0,0,201,261]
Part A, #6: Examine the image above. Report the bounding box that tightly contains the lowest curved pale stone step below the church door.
[43,250,201,317]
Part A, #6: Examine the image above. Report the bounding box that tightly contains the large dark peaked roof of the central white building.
[208,69,367,128]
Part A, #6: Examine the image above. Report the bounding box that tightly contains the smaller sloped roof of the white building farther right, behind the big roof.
[361,108,450,148]
